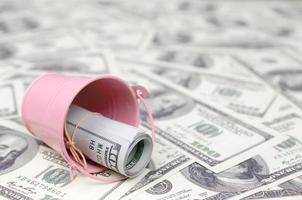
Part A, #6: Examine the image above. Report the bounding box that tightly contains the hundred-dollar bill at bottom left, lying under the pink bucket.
[0,122,145,200]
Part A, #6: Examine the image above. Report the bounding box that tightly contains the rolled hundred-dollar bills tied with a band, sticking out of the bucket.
[66,105,153,177]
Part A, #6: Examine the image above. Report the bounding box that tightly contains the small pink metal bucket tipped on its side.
[22,73,154,182]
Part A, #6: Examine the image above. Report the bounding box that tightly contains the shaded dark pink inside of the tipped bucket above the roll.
[73,77,139,126]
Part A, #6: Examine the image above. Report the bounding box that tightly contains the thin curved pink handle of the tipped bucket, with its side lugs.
[68,85,155,183]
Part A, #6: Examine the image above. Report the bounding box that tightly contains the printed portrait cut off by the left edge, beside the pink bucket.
[0,126,38,175]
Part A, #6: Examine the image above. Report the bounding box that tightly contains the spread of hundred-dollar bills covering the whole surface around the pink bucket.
[0,0,302,200]
